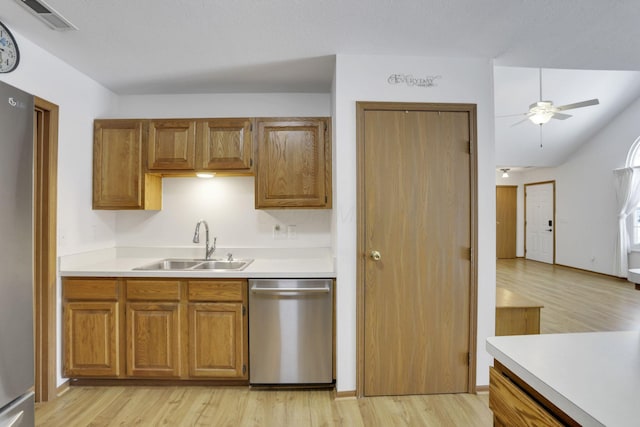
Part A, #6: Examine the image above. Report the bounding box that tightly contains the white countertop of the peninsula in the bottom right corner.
[486,331,640,427]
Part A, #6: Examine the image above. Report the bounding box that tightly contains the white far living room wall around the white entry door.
[496,95,640,275]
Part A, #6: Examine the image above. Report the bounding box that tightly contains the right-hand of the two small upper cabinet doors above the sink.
[196,119,253,174]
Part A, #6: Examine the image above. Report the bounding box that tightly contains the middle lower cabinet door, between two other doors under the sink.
[126,302,181,378]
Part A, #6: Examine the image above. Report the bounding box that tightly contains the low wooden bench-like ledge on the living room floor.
[496,287,544,336]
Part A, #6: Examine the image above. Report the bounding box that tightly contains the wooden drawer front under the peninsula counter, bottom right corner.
[489,368,564,426]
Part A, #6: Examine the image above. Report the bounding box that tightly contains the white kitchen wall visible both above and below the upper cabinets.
[103,93,331,248]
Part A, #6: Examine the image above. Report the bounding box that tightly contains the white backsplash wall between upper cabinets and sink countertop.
[116,177,331,253]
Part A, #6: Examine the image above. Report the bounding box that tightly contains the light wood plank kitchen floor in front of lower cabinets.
[36,386,492,427]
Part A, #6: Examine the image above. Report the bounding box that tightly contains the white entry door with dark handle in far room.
[525,182,555,264]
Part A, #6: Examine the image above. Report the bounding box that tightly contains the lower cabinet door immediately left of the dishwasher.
[189,303,247,379]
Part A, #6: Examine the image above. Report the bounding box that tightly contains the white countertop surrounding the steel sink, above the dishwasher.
[59,247,336,278]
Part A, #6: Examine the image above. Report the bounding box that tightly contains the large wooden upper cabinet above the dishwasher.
[255,117,331,209]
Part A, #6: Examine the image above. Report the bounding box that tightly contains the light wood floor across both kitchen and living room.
[36,259,640,427]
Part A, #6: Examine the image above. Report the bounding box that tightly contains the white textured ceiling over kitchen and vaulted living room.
[0,0,640,165]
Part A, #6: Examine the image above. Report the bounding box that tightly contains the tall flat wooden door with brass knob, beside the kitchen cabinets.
[358,103,475,396]
